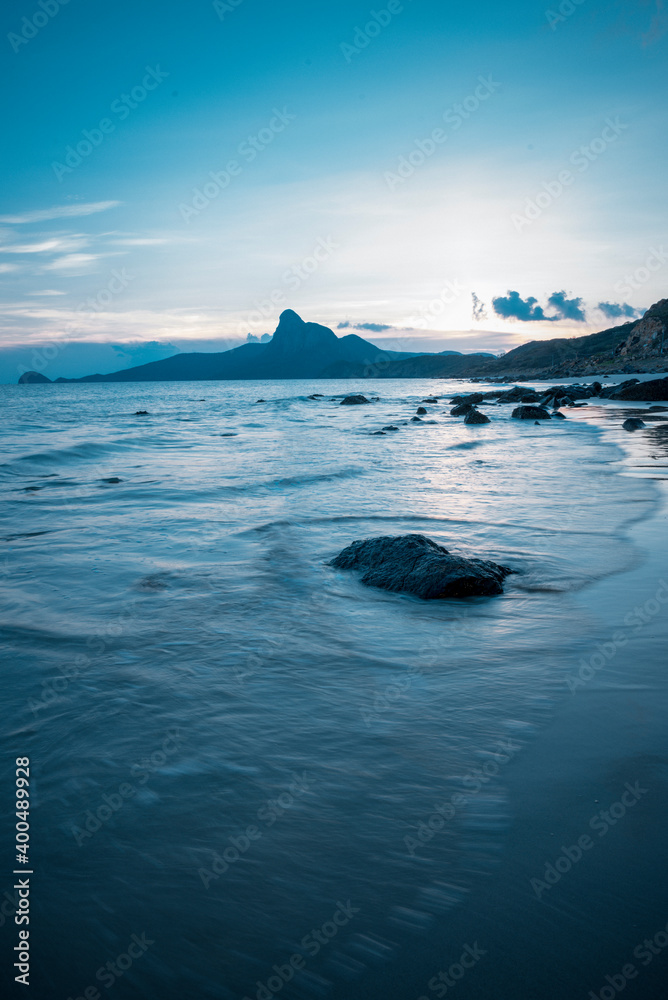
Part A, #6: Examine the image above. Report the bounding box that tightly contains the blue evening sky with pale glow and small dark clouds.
[0,0,668,381]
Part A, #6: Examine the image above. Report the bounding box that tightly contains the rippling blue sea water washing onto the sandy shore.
[0,380,666,1000]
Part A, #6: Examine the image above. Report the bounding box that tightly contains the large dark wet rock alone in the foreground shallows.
[330,535,512,601]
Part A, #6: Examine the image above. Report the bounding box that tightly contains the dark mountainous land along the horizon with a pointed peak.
[19,299,668,383]
